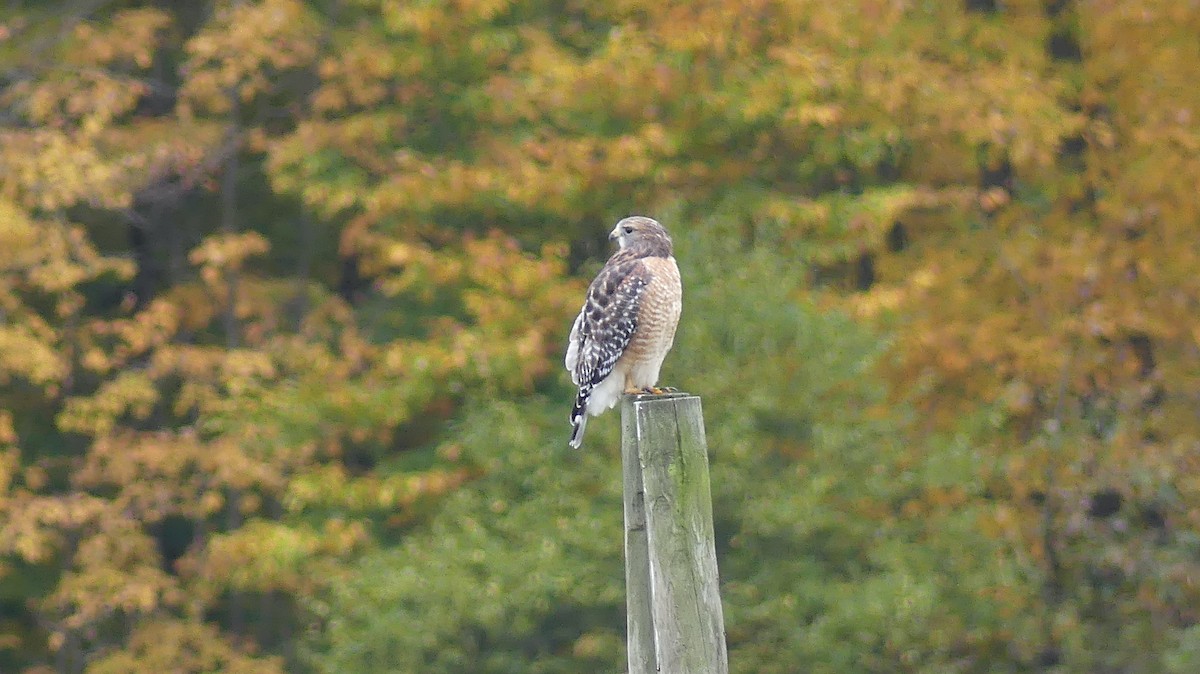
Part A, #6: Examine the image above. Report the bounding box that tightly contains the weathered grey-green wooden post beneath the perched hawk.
[620,393,730,674]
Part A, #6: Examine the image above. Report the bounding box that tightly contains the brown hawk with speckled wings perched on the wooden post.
[566,216,683,449]
